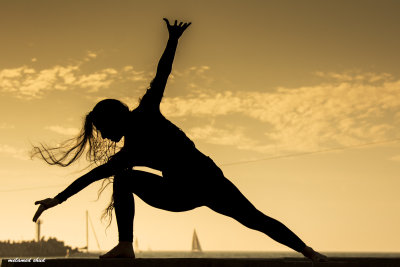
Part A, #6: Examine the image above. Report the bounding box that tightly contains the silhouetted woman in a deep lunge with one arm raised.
[33,19,326,261]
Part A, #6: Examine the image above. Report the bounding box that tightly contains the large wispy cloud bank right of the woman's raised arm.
[162,72,400,154]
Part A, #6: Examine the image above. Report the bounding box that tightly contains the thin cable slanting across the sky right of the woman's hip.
[220,138,400,166]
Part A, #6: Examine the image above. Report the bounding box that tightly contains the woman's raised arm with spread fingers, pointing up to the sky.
[141,18,191,108]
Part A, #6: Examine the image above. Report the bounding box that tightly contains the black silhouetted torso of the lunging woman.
[124,108,209,174]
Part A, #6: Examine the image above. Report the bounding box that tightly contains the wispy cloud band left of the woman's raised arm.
[0,52,147,99]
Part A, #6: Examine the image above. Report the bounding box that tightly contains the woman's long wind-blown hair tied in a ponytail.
[31,99,129,227]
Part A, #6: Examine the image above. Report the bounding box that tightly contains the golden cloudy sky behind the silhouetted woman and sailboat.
[0,0,400,252]
